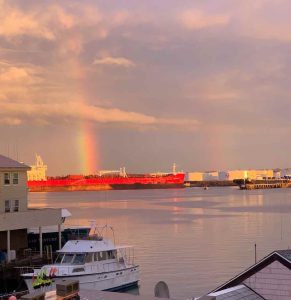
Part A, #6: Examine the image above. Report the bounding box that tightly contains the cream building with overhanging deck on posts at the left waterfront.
[0,155,70,261]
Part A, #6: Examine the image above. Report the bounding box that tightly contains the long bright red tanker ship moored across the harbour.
[27,160,185,192]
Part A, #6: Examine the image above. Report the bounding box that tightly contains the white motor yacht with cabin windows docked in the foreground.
[22,226,139,292]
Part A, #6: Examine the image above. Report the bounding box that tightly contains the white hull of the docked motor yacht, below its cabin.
[23,266,139,292]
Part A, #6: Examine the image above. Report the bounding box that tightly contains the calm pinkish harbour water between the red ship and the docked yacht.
[29,187,291,298]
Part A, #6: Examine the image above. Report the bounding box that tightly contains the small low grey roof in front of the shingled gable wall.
[208,284,264,300]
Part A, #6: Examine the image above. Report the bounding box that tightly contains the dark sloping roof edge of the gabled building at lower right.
[211,249,291,293]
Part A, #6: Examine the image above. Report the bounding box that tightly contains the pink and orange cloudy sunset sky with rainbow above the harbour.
[0,0,291,175]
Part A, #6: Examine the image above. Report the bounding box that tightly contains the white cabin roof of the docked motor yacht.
[57,239,131,253]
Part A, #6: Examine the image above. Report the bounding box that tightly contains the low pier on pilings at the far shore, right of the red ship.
[233,178,291,190]
